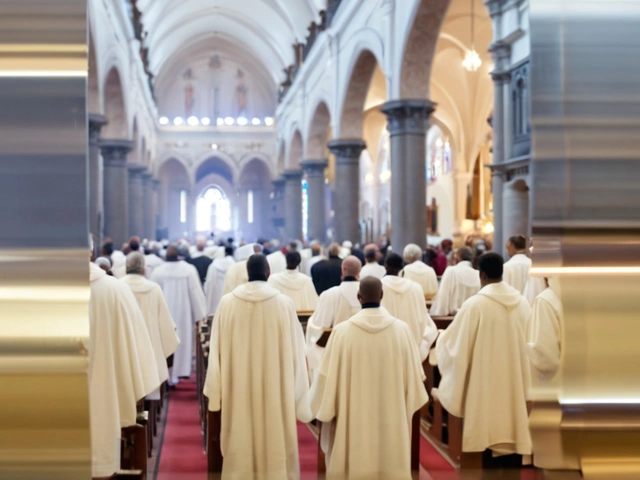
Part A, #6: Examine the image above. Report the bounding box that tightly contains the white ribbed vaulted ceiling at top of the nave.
[137,0,326,87]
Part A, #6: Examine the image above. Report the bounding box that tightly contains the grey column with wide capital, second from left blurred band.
[99,140,133,249]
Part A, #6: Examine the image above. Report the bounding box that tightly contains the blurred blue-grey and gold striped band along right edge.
[530,0,640,480]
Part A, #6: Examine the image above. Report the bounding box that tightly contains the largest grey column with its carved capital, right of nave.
[382,100,435,252]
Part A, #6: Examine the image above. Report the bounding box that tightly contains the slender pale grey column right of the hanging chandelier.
[489,41,511,255]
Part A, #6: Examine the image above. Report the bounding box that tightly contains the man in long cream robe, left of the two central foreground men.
[204,255,313,480]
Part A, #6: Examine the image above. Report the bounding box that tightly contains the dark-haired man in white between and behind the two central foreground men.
[269,252,318,312]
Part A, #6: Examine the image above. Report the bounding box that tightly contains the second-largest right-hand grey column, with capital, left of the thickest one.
[327,139,367,244]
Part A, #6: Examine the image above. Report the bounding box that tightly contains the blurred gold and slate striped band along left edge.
[0,0,91,480]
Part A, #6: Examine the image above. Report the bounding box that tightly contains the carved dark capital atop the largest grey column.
[380,99,436,136]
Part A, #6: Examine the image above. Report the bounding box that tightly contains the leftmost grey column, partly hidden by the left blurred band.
[89,113,107,244]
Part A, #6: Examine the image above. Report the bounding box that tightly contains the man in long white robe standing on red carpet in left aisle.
[151,245,207,385]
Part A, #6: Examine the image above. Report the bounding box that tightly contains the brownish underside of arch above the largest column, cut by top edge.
[400,0,451,99]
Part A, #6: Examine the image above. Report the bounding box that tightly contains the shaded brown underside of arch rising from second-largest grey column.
[339,50,379,139]
